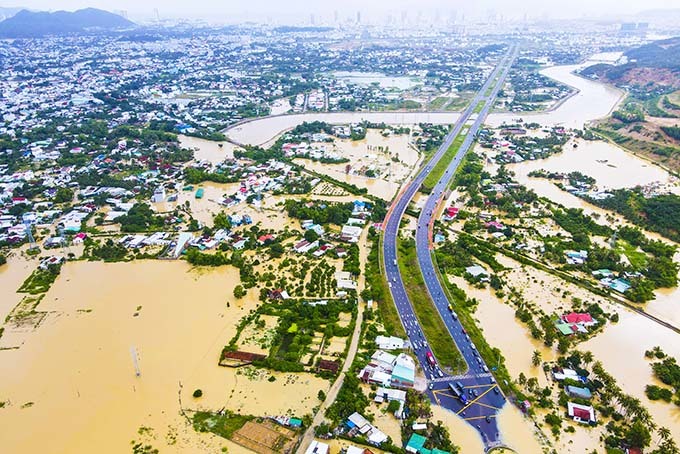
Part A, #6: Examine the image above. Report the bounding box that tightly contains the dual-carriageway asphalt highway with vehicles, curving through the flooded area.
[382,45,517,450]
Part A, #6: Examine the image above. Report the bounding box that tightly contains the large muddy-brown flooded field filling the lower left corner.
[0,261,328,453]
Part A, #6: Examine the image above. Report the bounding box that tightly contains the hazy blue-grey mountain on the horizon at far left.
[0,8,135,38]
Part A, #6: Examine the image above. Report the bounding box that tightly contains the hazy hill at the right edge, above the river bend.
[581,37,680,92]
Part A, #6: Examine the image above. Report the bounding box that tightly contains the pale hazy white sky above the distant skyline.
[0,0,680,21]
